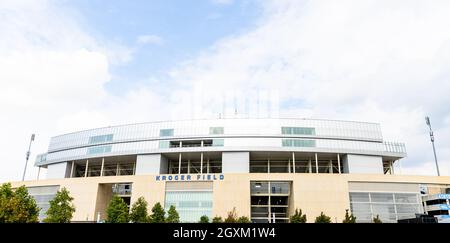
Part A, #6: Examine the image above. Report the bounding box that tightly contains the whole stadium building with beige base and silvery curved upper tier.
[9,119,450,222]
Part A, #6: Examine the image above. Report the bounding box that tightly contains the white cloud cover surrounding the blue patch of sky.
[0,0,450,180]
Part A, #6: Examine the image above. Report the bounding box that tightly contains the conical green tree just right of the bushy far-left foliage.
[44,187,75,223]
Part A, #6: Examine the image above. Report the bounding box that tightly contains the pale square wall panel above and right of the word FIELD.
[222,152,250,173]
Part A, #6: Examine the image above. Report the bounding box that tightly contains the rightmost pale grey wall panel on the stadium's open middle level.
[342,154,383,174]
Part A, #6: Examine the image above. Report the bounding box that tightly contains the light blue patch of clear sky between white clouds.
[66,0,261,94]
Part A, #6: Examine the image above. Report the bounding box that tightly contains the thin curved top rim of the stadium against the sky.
[52,117,380,138]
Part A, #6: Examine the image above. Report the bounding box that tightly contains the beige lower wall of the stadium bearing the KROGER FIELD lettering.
[12,173,450,222]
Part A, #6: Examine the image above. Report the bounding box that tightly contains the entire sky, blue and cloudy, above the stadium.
[0,0,450,182]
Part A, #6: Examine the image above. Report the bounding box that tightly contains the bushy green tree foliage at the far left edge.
[0,183,39,223]
